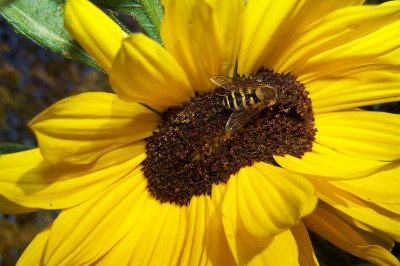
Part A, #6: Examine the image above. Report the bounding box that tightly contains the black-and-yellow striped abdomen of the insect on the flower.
[222,89,262,110]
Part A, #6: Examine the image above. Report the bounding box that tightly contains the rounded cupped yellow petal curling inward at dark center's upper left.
[110,33,194,109]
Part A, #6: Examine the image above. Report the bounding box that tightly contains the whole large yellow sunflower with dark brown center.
[0,0,400,265]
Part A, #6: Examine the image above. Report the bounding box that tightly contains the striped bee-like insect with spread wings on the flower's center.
[210,75,278,132]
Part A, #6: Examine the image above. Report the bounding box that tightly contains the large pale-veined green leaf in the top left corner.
[0,0,101,70]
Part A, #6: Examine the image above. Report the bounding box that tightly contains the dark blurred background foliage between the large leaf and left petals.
[0,16,111,145]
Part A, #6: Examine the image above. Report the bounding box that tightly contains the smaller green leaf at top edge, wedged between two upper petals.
[92,0,164,44]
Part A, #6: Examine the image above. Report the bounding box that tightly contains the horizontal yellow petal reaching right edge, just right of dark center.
[315,111,400,161]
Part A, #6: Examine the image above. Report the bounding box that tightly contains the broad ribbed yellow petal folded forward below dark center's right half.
[222,163,317,263]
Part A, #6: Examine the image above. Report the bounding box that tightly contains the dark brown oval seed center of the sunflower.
[142,70,316,205]
